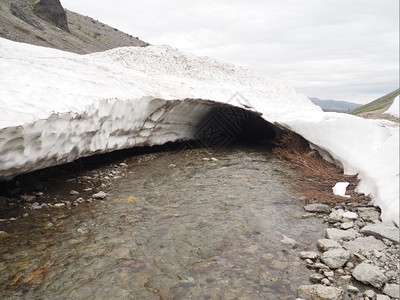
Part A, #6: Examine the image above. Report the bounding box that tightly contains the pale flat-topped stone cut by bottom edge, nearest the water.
[297,284,344,300]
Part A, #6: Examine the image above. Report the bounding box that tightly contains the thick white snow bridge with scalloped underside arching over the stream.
[0,38,399,224]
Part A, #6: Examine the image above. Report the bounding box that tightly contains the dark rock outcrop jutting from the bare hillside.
[34,0,70,32]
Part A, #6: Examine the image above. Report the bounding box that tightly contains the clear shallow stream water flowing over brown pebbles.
[0,146,324,299]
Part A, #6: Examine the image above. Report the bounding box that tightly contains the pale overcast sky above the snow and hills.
[61,0,399,103]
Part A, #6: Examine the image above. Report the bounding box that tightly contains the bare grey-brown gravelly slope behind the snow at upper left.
[0,0,149,54]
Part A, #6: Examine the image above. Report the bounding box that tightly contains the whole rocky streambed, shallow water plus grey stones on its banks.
[0,146,399,300]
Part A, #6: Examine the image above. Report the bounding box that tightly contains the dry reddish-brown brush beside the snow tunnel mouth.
[273,133,370,204]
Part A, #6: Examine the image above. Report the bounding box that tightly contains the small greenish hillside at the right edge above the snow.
[349,89,399,121]
